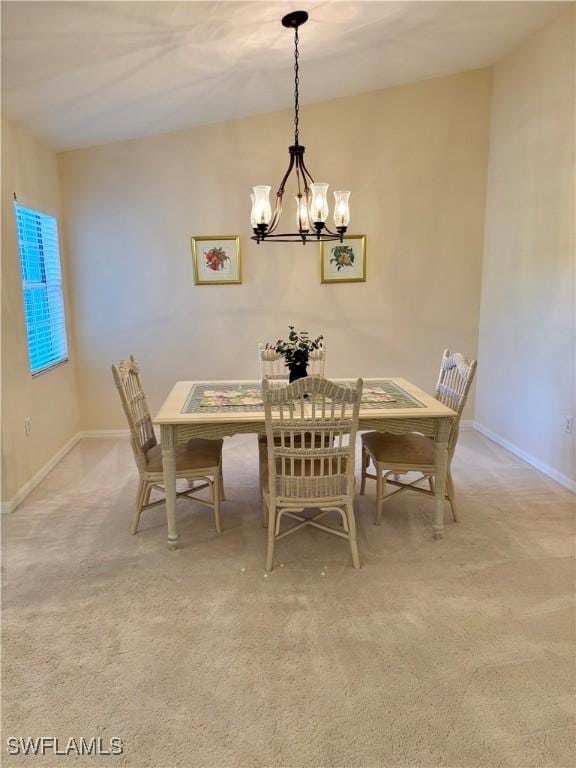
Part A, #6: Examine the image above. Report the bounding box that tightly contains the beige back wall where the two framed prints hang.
[60,70,491,429]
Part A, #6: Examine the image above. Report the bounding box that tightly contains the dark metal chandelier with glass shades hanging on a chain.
[250,11,350,244]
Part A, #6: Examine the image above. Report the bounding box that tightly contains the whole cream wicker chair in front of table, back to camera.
[260,376,362,571]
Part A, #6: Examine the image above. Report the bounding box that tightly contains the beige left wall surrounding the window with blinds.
[2,122,79,501]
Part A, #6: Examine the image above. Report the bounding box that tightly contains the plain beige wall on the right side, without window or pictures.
[476,7,575,486]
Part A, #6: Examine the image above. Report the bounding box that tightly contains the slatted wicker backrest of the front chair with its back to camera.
[262,376,362,500]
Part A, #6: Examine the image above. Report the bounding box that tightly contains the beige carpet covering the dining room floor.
[2,431,575,768]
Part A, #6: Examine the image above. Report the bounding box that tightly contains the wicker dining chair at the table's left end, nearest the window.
[112,355,225,534]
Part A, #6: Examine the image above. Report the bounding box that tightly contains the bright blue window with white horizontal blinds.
[14,202,68,374]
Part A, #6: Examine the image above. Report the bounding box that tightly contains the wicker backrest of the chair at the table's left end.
[112,355,158,470]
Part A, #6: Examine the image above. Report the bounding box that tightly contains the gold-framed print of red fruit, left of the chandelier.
[192,235,242,285]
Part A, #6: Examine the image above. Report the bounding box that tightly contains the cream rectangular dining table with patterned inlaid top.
[154,377,457,549]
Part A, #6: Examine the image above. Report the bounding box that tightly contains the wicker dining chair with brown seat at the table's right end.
[360,349,476,525]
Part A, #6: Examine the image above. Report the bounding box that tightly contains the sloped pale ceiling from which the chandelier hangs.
[2,0,566,150]
